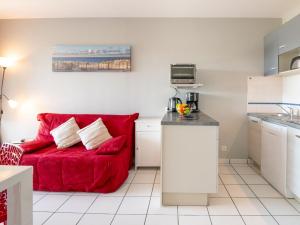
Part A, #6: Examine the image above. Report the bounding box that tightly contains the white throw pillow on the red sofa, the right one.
[77,118,111,150]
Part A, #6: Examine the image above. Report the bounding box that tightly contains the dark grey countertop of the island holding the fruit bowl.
[161,111,219,126]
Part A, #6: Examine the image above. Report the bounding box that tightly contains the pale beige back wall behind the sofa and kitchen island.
[0,18,281,158]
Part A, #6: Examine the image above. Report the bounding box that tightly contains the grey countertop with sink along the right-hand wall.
[248,113,300,129]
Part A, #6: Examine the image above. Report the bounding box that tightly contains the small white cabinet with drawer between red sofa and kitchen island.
[135,118,161,168]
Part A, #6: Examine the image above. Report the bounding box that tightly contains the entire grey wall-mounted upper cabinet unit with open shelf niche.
[264,15,300,76]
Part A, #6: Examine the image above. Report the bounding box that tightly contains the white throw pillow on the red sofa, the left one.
[50,117,80,148]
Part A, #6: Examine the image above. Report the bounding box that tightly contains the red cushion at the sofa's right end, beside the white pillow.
[96,135,127,155]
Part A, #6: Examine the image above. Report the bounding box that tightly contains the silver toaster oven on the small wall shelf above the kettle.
[171,64,196,84]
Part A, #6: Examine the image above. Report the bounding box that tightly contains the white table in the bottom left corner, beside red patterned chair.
[0,166,32,225]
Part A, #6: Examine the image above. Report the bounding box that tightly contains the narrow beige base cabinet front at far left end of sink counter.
[248,116,261,166]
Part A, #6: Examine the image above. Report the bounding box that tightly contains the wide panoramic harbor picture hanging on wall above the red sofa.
[52,45,131,72]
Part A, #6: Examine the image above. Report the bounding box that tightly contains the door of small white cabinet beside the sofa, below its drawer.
[136,131,161,166]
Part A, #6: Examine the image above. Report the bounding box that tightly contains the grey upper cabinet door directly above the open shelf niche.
[278,15,300,55]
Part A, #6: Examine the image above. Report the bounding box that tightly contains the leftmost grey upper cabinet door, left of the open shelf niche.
[264,31,278,76]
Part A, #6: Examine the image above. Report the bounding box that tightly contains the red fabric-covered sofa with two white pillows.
[20,113,138,193]
